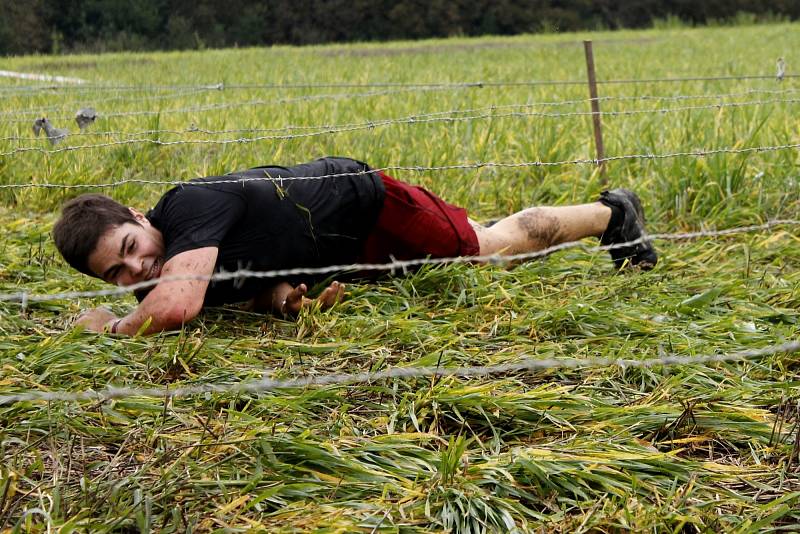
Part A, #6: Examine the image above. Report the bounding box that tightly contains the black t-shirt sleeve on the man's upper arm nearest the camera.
[156,185,247,261]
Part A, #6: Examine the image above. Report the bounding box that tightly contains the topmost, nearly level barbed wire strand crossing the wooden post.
[0,74,800,94]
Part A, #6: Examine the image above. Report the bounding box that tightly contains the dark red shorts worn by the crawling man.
[361,172,480,263]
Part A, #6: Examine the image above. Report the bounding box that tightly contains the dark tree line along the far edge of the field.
[0,0,800,55]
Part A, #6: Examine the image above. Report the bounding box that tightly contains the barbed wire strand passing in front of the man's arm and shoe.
[0,219,800,307]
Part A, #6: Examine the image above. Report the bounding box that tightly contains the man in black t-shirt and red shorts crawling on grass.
[53,158,657,335]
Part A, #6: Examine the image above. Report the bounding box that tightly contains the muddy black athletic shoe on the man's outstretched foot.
[600,189,658,270]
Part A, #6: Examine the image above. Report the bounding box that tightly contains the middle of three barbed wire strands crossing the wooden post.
[0,94,800,144]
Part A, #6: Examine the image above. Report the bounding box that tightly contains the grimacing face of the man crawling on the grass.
[89,208,164,286]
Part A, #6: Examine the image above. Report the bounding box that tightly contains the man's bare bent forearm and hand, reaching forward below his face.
[76,247,219,335]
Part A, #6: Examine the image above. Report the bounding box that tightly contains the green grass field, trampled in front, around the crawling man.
[0,19,800,532]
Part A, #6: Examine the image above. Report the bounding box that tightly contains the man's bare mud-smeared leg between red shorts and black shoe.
[470,202,611,255]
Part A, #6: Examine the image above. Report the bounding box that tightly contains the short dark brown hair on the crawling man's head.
[53,194,139,278]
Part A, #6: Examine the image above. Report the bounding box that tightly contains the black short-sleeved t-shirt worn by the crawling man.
[147,158,385,306]
